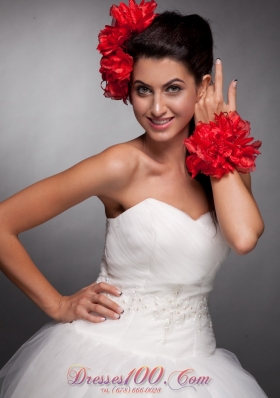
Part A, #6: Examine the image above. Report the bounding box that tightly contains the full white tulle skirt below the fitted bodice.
[0,322,267,398]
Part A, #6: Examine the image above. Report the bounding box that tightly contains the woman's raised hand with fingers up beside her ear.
[194,58,237,124]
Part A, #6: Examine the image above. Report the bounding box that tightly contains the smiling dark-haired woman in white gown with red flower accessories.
[0,0,266,398]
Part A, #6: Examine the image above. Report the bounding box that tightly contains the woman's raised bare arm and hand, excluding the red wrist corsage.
[195,59,264,254]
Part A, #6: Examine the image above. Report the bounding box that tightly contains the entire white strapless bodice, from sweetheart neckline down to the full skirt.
[73,198,230,358]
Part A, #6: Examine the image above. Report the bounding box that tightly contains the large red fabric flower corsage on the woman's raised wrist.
[184,112,262,178]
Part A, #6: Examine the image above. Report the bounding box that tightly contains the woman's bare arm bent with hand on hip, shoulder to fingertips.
[0,145,137,322]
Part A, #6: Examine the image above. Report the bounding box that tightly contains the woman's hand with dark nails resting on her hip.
[53,282,123,323]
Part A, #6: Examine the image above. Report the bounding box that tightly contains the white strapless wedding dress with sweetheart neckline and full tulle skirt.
[0,198,267,398]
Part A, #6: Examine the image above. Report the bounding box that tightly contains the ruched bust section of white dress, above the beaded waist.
[100,198,230,295]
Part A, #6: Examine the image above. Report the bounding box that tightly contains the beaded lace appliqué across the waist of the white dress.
[97,277,212,344]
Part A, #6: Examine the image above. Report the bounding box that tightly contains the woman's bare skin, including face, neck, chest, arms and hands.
[0,58,264,323]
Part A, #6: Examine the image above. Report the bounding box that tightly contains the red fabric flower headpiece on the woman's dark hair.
[97,0,158,104]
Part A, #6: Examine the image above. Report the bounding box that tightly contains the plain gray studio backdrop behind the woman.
[0,0,280,398]
